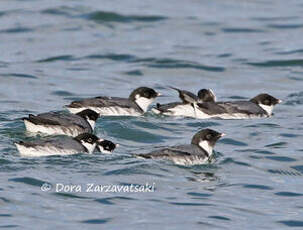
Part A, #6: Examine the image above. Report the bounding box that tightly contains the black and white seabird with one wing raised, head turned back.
[152,87,216,118]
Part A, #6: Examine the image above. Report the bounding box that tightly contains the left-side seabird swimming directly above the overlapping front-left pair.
[23,109,99,137]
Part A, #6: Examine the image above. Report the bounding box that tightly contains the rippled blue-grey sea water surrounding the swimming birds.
[0,0,303,229]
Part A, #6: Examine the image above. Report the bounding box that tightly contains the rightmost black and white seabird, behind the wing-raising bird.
[197,93,282,119]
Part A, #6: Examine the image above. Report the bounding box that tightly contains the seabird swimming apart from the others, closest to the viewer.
[135,129,225,165]
